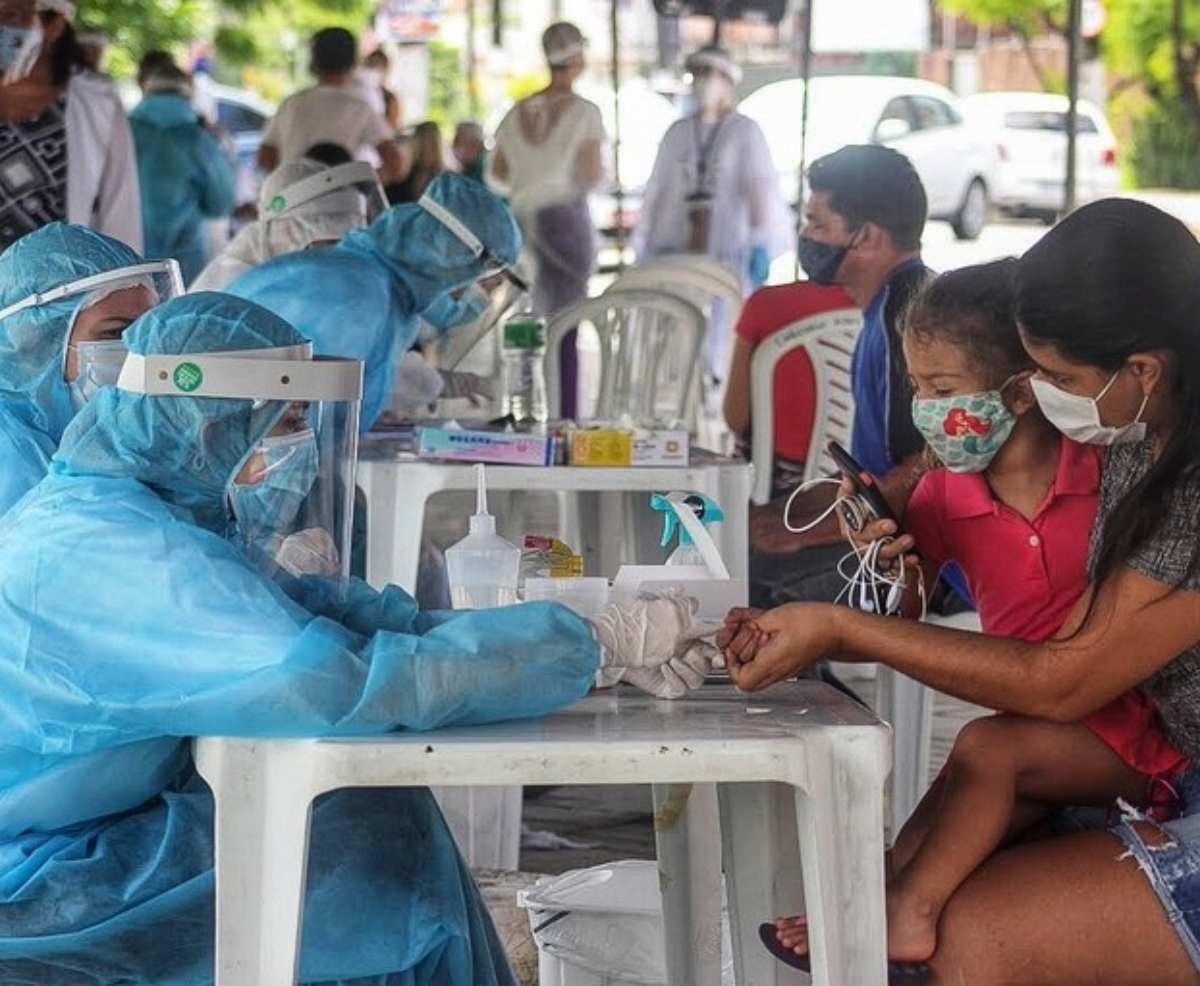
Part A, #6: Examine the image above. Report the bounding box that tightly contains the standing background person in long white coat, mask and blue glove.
[634,47,791,379]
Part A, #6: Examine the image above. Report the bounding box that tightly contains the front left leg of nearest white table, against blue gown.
[197,741,311,986]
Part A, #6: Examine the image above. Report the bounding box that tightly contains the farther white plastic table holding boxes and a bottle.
[358,443,754,593]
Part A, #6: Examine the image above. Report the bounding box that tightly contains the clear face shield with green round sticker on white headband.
[119,343,362,590]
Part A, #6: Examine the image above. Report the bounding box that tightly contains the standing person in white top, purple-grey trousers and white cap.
[487,22,605,417]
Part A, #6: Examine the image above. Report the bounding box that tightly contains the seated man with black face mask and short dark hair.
[750,145,929,607]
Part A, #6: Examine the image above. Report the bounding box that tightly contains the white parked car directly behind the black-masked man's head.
[738,76,997,240]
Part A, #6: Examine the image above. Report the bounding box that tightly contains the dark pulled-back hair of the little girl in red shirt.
[901,257,1036,386]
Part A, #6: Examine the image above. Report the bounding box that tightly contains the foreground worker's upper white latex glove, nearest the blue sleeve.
[592,594,700,680]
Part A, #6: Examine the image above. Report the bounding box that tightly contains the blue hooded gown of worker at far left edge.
[0,223,142,515]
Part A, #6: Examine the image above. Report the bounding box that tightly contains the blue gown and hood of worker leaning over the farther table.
[227,174,521,432]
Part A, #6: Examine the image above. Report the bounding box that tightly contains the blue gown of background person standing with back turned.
[130,92,236,284]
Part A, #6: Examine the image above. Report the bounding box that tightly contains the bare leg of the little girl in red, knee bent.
[888,715,1146,962]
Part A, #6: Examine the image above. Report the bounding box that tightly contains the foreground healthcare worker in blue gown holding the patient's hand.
[0,294,702,986]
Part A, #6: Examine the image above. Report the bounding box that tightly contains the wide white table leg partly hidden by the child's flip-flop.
[718,783,808,986]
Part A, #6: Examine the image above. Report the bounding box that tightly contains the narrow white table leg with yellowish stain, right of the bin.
[654,784,721,986]
